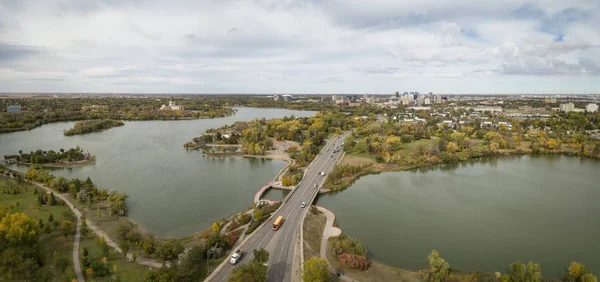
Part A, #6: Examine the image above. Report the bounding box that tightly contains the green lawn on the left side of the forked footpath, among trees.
[0,176,77,281]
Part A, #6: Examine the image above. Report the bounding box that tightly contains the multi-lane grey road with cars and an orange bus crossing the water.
[207,133,349,282]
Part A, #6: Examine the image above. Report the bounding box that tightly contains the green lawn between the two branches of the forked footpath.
[79,232,150,281]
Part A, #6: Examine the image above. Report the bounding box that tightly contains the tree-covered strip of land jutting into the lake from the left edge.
[4,146,96,167]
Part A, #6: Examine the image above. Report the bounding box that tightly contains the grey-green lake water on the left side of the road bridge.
[0,108,316,237]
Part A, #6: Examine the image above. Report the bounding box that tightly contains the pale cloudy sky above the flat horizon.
[0,0,600,93]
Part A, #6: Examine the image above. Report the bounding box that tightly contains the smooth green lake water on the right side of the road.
[318,156,600,278]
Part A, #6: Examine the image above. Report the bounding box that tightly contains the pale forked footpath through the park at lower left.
[32,182,164,268]
